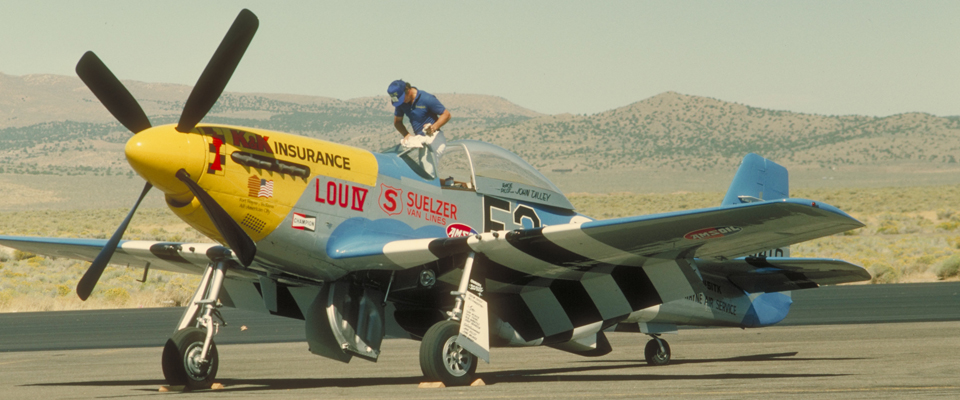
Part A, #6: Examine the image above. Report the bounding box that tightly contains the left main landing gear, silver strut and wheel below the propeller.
[162,260,232,389]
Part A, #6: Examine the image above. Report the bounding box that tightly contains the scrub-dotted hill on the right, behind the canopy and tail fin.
[456,92,960,171]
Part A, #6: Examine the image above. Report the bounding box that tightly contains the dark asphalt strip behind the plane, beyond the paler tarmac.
[0,282,960,352]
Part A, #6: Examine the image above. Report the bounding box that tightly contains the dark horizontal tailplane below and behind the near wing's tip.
[696,257,870,293]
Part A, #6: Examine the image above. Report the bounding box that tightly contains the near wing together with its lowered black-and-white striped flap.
[316,199,863,340]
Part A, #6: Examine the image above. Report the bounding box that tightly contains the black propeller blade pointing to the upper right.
[177,9,260,132]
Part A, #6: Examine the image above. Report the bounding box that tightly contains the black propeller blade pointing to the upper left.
[76,51,150,133]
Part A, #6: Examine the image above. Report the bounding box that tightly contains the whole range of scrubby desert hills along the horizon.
[0,73,960,179]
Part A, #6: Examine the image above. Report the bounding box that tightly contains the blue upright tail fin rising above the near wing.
[720,153,790,207]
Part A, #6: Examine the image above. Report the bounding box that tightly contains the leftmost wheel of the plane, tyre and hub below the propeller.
[162,328,220,389]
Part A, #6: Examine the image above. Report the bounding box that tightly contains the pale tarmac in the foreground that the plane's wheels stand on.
[0,322,960,399]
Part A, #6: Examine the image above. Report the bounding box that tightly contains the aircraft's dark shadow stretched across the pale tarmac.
[24,352,858,392]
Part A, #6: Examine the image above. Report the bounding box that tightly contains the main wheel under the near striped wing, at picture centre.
[420,321,478,386]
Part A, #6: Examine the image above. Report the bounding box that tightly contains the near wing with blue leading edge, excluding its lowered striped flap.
[327,199,863,277]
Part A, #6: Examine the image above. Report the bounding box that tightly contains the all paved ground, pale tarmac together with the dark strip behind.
[0,283,960,399]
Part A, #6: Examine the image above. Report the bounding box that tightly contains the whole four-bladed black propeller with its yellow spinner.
[76,9,260,300]
